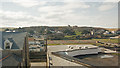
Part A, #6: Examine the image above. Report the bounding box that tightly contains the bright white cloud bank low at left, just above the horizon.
[0,10,61,27]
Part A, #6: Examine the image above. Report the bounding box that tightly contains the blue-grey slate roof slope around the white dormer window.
[0,32,27,49]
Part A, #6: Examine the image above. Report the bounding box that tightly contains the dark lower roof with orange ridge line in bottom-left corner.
[0,50,22,66]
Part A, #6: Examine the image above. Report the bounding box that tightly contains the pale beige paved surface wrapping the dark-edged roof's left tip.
[48,45,86,68]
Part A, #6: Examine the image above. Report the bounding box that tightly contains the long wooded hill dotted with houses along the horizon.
[2,25,120,40]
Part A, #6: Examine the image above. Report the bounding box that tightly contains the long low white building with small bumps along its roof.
[66,45,102,56]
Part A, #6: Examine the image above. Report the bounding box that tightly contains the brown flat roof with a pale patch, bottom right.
[75,54,119,66]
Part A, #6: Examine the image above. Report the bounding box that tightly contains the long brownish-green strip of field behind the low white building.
[48,39,120,46]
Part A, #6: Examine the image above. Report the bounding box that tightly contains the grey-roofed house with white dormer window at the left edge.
[0,32,29,68]
